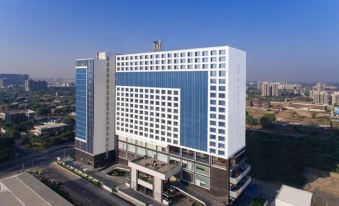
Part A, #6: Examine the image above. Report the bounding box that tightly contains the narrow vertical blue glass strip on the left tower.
[76,68,87,141]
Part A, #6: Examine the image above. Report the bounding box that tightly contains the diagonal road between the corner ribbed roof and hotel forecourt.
[44,164,132,206]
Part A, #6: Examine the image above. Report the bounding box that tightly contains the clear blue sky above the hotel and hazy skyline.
[0,0,339,82]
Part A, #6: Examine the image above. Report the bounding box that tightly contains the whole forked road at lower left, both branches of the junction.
[0,143,131,206]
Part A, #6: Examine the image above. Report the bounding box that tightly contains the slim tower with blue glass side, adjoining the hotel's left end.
[75,52,115,167]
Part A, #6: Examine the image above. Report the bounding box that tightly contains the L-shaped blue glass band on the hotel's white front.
[116,71,208,151]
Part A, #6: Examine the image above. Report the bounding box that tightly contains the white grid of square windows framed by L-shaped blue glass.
[116,86,180,146]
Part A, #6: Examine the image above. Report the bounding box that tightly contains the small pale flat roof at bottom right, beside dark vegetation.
[276,185,312,206]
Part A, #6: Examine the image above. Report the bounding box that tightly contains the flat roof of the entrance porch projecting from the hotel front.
[133,157,178,174]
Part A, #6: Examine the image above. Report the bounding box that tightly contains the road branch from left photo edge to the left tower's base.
[0,143,74,178]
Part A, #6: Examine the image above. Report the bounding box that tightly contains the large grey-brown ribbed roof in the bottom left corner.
[0,172,72,206]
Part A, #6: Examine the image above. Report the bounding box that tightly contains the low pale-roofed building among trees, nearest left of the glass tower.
[33,122,67,136]
